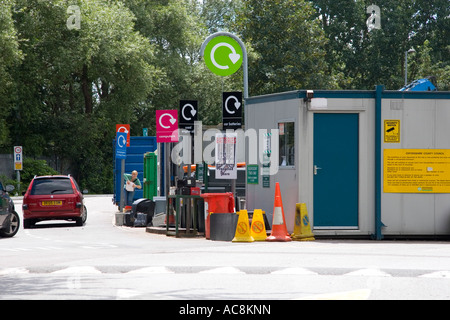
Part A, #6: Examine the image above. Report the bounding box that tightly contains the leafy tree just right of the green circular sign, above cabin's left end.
[236,0,331,95]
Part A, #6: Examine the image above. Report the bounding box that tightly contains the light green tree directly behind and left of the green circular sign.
[125,0,242,130]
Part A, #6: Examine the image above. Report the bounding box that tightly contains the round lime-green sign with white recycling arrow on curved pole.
[204,36,243,77]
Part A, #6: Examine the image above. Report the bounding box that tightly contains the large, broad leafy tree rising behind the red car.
[10,0,158,192]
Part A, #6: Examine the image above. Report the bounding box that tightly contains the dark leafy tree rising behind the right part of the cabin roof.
[313,0,450,90]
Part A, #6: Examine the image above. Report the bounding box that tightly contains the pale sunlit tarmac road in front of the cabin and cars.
[0,195,450,302]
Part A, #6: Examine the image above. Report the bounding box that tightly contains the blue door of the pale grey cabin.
[313,113,359,229]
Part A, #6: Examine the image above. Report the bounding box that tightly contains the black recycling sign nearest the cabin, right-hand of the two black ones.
[222,92,242,130]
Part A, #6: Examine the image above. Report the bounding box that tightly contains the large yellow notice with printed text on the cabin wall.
[383,149,450,193]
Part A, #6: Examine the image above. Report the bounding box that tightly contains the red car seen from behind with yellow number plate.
[22,175,87,229]
